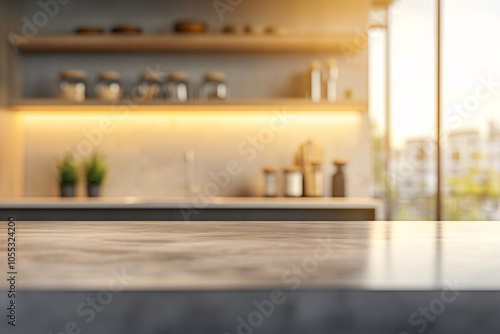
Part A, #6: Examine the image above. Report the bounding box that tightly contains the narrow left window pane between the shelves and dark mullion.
[387,0,437,220]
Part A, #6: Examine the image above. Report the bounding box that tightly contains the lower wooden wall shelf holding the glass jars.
[9,98,368,113]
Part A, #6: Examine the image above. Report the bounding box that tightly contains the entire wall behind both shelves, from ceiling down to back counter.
[7,0,372,196]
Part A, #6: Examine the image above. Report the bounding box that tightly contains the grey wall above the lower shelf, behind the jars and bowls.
[17,0,370,99]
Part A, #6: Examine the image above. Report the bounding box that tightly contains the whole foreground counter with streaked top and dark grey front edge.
[0,221,500,334]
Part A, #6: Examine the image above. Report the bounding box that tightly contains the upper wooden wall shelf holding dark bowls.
[11,33,366,53]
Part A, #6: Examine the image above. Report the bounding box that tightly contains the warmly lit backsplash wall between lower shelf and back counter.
[23,111,372,196]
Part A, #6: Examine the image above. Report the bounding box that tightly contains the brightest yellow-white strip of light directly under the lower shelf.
[19,111,361,136]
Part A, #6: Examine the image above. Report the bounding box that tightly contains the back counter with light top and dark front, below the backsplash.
[0,197,382,221]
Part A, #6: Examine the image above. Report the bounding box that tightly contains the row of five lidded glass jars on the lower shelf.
[59,70,229,102]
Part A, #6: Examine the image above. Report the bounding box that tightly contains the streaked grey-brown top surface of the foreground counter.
[0,222,500,292]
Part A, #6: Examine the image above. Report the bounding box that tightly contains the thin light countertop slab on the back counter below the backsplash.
[0,197,382,209]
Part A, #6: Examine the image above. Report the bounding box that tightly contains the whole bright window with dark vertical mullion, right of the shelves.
[386,0,500,220]
